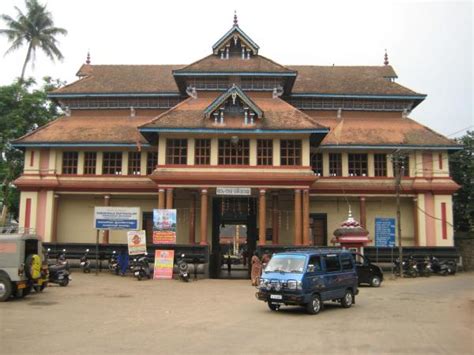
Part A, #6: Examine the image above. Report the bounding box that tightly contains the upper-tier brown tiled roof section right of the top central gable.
[288,65,420,95]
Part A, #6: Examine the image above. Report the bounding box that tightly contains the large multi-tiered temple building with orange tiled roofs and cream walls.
[14,13,460,270]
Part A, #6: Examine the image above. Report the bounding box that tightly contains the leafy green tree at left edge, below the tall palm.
[0,78,62,225]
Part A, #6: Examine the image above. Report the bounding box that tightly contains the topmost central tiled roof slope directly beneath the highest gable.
[175,54,294,73]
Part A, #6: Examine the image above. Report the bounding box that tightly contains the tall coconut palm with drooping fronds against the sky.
[0,0,67,83]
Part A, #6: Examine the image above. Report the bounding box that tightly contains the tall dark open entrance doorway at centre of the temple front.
[209,197,257,278]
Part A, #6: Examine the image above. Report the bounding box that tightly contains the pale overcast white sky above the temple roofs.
[0,0,474,138]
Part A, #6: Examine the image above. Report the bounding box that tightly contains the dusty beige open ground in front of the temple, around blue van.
[0,272,474,354]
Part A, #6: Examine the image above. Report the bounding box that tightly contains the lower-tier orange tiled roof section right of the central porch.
[308,112,458,147]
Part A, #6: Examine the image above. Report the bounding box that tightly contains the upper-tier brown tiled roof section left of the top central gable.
[52,65,182,94]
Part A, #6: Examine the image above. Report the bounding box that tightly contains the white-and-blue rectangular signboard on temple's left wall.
[94,207,140,230]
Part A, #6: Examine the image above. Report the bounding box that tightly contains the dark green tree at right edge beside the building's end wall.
[450,131,474,232]
